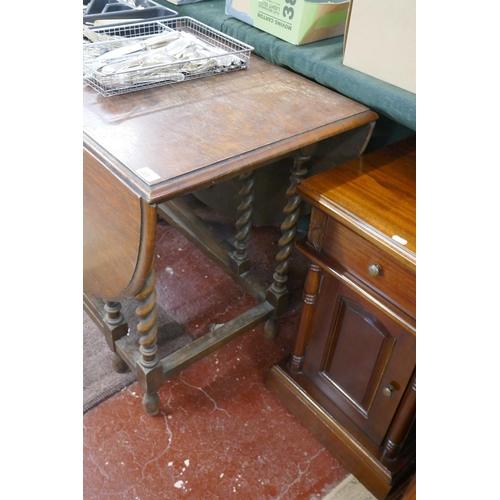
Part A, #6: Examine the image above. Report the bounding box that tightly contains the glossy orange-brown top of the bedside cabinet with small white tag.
[297,135,417,266]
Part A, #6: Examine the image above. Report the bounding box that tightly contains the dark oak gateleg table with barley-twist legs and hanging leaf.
[83,55,378,415]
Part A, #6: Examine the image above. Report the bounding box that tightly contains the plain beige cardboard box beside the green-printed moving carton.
[344,0,417,94]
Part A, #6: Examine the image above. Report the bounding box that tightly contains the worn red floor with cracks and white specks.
[83,196,348,500]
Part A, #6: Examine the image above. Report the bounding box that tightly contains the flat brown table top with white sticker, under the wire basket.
[83,55,377,203]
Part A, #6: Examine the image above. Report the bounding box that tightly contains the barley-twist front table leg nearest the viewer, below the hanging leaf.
[135,267,163,415]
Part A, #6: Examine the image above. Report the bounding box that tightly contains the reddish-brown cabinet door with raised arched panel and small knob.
[303,269,415,445]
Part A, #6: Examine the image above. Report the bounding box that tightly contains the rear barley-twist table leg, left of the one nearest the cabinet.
[230,170,255,275]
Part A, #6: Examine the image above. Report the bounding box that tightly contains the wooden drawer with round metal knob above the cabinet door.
[313,214,416,318]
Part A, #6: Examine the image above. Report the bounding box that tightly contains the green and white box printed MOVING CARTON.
[226,0,349,45]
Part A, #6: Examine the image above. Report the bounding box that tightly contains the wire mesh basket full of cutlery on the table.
[83,17,253,97]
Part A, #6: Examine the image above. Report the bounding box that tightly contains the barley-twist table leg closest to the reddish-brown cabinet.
[264,144,316,339]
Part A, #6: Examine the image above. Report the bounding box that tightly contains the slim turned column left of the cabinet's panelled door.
[290,262,322,373]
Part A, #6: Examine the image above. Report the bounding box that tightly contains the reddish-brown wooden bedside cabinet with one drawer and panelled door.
[267,137,416,499]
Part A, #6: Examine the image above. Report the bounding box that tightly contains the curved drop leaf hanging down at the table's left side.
[83,149,156,300]
